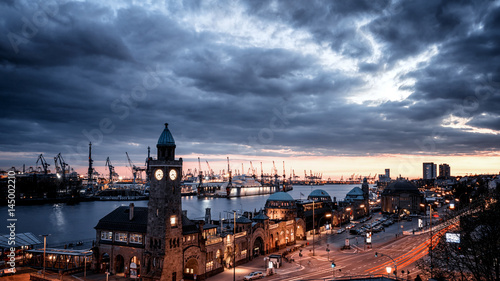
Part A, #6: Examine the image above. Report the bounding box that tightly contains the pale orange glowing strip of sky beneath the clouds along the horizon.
[76,152,500,180]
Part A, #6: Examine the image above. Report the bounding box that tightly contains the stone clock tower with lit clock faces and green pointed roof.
[143,123,183,281]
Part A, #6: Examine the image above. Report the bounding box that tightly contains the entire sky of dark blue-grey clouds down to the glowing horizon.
[0,0,500,177]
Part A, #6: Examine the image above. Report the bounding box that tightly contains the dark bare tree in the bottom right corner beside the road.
[418,183,500,281]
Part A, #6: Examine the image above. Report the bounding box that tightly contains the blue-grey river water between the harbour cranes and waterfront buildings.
[0,184,368,246]
